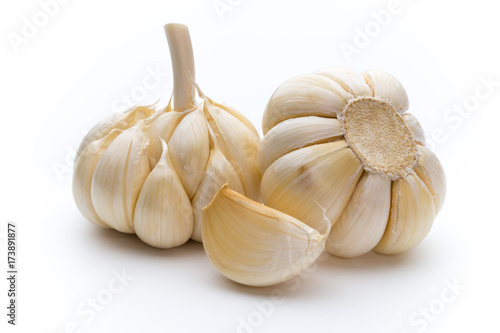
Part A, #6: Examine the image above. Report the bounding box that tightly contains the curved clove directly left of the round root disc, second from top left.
[257,116,343,174]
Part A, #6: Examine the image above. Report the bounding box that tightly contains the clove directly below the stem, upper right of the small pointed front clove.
[168,109,210,199]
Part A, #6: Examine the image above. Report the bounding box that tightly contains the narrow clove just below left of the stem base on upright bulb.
[148,111,182,169]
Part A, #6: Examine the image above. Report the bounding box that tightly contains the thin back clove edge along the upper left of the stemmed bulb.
[75,106,155,161]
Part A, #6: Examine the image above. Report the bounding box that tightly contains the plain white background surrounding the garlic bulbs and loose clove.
[0,0,500,333]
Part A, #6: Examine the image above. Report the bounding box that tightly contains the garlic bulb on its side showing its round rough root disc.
[257,67,446,257]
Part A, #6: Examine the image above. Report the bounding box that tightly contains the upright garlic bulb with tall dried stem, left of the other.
[73,24,261,248]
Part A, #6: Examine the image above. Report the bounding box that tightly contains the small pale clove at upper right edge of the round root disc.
[363,69,409,114]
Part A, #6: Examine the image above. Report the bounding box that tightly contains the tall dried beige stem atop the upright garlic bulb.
[163,23,195,111]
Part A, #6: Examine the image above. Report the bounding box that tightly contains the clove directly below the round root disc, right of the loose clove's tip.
[325,172,391,257]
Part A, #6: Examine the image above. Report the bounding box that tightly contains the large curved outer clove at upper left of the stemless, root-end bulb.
[262,74,351,134]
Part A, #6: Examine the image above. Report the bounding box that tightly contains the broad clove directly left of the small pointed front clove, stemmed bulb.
[91,122,151,233]
